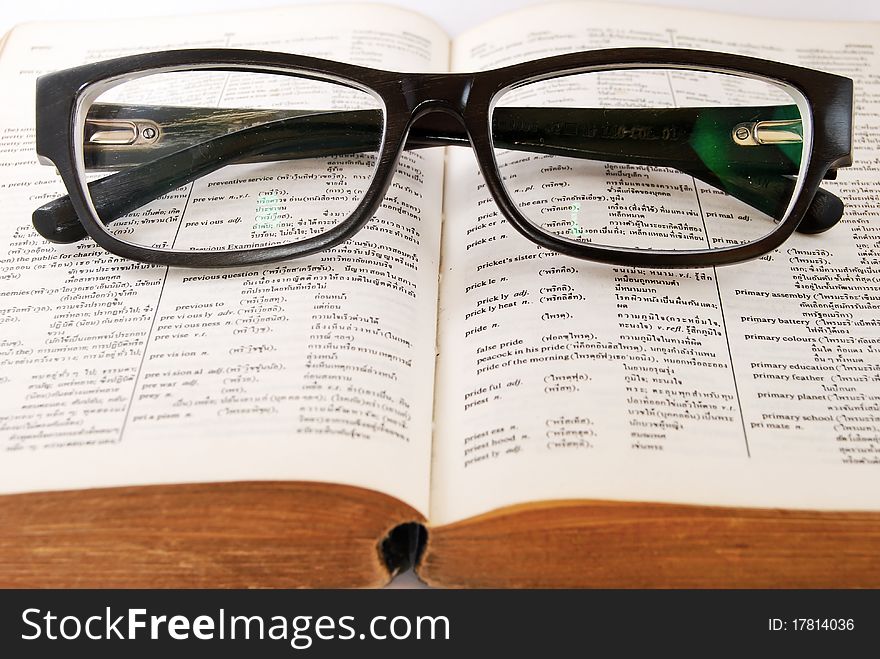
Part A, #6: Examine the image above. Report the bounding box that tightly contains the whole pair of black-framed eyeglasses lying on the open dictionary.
[33,48,853,267]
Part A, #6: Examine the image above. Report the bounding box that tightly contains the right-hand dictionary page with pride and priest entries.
[431,3,880,524]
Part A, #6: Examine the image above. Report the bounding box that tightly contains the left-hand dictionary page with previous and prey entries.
[0,5,449,512]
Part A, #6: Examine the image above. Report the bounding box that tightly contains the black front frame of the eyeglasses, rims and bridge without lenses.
[36,48,853,267]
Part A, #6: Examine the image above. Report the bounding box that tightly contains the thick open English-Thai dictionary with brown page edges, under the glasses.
[0,3,880,586]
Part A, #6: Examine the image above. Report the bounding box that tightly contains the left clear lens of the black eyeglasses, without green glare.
[79,70,384,252]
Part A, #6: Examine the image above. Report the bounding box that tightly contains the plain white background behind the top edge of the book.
[0,0,880,588]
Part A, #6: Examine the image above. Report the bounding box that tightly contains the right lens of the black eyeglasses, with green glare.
[492,69,808,251]
